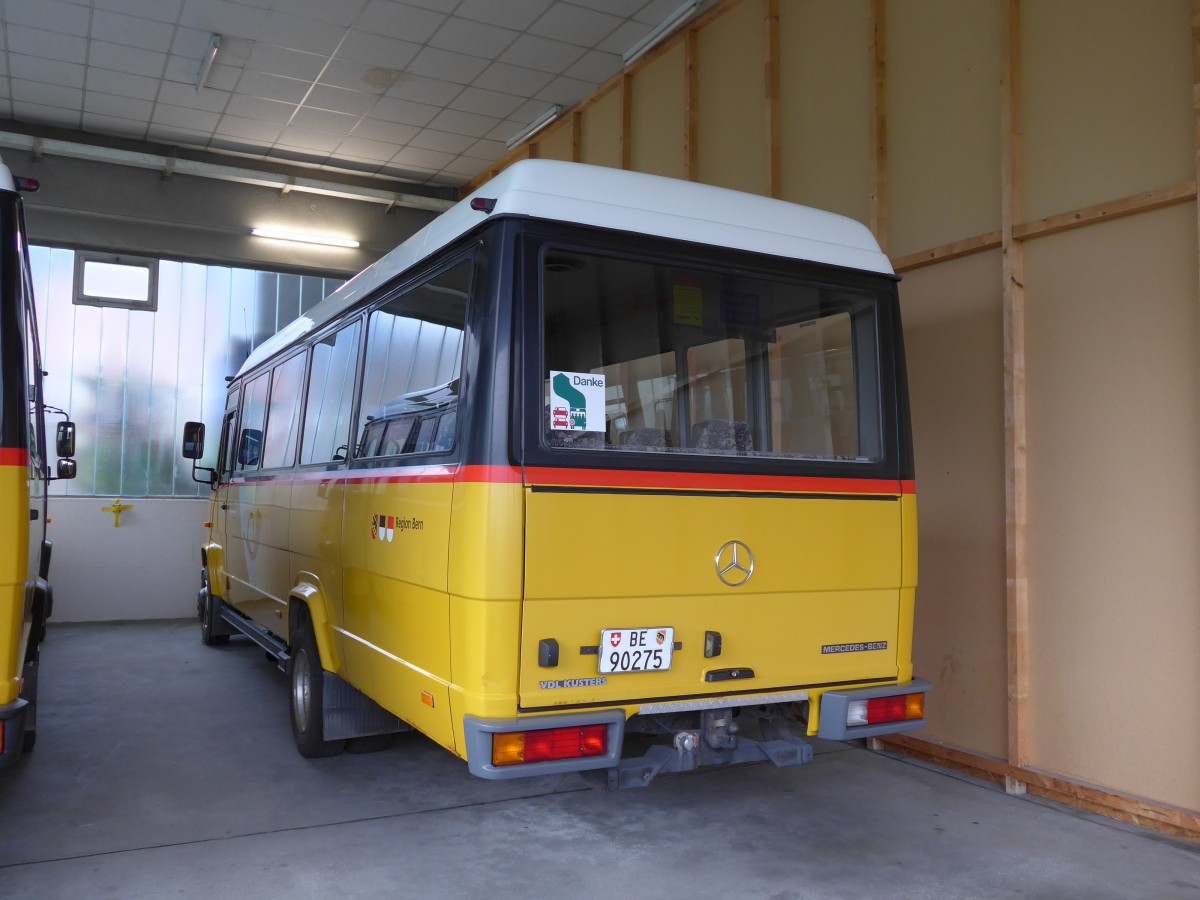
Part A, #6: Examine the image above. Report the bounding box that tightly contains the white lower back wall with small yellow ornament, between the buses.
[49,497,209,622]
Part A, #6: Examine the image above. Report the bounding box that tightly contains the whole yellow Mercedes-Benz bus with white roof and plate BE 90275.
[184,160,929,787]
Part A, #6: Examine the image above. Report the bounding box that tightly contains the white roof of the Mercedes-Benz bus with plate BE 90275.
[239,160,893,374]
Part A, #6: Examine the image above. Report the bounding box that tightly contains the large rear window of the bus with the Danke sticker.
[541,248,883,462]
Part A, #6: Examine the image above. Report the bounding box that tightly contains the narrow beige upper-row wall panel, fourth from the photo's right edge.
[696,0,768,193]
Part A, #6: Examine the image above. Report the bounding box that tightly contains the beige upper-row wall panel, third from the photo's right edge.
[779,0,871,222]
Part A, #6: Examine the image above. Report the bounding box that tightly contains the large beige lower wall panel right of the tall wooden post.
[1025,204,1200,809]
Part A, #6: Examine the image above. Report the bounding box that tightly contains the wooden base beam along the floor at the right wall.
[868,734,1200,844]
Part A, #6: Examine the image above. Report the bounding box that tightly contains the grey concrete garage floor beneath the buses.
[0,622,1200,900]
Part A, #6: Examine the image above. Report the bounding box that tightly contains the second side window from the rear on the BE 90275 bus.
[300,322,361,464]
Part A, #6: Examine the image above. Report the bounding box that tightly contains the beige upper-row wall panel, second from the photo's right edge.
[887,0,1001,256]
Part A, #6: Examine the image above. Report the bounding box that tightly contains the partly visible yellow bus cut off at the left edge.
[0,163,76,768]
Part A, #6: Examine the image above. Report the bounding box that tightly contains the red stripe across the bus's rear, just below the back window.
[526,468,913,496]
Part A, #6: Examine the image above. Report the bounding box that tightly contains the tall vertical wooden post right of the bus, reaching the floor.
[1001,0,1030,777]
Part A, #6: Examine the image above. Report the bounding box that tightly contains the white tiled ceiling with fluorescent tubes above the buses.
[0,0,696,188]
